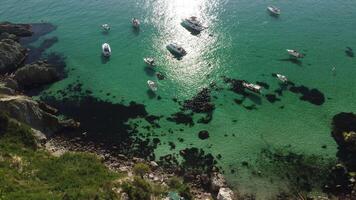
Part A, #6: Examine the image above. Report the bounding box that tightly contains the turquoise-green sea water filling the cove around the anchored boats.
[0,0,356,199]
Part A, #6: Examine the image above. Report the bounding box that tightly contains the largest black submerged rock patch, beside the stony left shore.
[41,90,157,159]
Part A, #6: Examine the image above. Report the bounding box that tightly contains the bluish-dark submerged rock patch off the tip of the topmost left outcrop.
[20,23,57,45]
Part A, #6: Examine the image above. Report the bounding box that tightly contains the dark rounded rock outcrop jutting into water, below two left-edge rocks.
[14,61,59,88]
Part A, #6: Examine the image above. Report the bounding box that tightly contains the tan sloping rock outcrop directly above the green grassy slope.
[0,95,79,135]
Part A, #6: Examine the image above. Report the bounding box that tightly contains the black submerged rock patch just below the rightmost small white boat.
[289,85,325,106]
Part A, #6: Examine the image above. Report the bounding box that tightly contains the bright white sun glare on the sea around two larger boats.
[146,0,224,95]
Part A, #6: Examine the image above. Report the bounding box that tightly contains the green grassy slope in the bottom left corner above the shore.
[0,113,119,200]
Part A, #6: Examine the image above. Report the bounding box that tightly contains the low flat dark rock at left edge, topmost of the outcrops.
[0,22,33,37]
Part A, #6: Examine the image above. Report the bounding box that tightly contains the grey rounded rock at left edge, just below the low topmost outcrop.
[0,39,26,72]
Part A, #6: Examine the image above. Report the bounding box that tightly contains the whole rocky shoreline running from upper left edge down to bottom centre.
[0,22,234,200]
